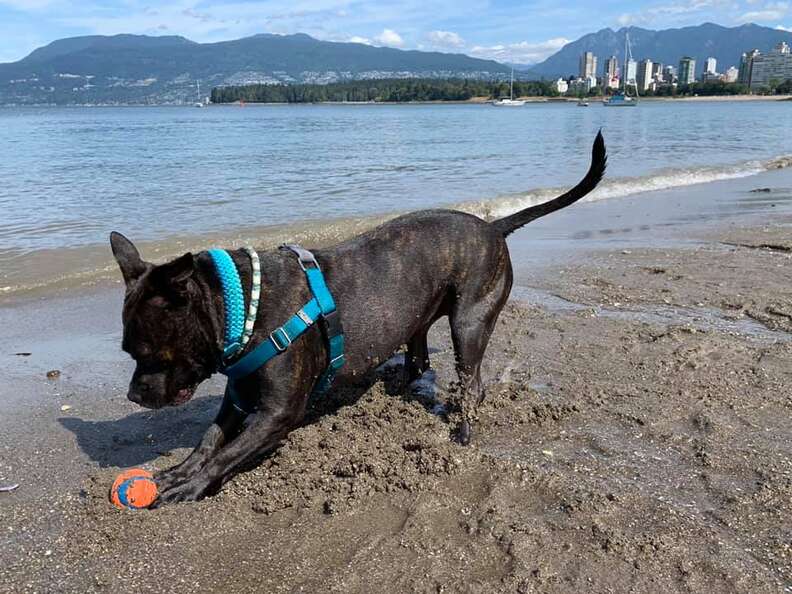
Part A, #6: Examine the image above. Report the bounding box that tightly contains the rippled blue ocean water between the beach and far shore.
[0,101,792,292]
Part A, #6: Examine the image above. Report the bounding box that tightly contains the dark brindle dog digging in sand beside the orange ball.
[110,132,607,506]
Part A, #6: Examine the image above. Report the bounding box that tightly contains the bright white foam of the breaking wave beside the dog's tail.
[456,155,792,219]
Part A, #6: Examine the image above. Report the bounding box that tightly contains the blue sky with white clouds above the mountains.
[0,0,792,63]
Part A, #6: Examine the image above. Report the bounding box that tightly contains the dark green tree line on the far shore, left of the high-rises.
[212,79,558,103]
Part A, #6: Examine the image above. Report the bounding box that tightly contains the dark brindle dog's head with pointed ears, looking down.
[110,233,217,408]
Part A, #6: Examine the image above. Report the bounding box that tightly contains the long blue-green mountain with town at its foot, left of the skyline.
[0,34,509,104]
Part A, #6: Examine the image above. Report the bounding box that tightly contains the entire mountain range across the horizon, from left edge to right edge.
[0,23,792,105]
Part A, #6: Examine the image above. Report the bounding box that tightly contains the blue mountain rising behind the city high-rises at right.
[528,23,792,79]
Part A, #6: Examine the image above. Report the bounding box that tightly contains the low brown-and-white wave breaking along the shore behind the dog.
[0,155,792,301]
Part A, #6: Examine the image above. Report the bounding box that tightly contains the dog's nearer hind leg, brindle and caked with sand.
[449,269,511,445]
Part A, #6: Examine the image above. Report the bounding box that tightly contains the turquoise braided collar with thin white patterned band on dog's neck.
[209,247,261,362]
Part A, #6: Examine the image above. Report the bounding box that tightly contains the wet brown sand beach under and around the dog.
[0,172,792,592]
